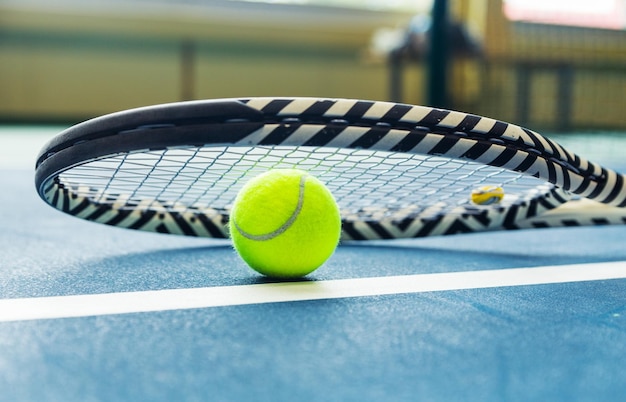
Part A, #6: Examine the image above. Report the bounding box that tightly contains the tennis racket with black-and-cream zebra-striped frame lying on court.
[35,98,626,240]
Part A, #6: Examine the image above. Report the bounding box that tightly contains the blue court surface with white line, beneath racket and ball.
[0,126,626,401]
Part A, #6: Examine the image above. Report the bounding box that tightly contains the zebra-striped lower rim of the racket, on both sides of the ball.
[45,182,576,240]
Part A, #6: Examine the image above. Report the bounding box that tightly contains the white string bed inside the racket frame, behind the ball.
[59,146,547,220]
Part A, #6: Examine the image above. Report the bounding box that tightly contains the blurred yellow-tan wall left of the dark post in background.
[0,0,418,121]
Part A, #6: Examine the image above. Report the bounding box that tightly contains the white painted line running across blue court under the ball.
[0,261,626,322]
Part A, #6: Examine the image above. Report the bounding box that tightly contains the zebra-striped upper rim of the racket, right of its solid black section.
[238,98,626,207]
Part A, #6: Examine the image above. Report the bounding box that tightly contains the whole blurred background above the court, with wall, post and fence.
[0,0,626,132]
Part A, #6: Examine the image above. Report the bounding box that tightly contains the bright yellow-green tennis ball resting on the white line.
[229,169,341,278]
